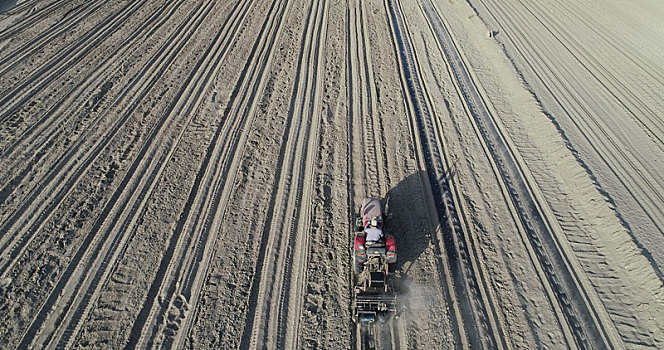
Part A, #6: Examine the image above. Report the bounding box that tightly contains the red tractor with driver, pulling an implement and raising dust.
[353,198,397,323]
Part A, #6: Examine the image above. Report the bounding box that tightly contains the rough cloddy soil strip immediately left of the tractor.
[294,2,350,348]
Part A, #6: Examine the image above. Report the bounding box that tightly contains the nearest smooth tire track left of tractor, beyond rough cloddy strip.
[241,0,328,348]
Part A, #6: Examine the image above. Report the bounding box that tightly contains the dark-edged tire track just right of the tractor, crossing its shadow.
[385,0,508,348]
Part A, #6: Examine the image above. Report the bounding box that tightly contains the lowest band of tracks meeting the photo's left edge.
[0,0,209,292]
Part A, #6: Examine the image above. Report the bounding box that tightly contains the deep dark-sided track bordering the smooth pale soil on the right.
[422,1,620,348]
